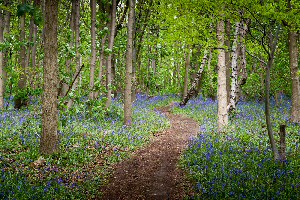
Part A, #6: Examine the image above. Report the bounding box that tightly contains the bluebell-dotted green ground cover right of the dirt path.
[173,97,300,199]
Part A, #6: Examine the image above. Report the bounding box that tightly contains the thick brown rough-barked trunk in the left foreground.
[40,0,59,154]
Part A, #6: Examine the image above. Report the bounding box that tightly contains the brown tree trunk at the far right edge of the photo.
[288,30,300,123]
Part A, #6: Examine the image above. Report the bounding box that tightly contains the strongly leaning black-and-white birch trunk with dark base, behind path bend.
[179,52,207,106]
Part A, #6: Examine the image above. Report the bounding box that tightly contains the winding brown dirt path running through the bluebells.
[102,106,199,200]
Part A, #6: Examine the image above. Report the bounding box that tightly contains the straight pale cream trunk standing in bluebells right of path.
[217,21,228,132]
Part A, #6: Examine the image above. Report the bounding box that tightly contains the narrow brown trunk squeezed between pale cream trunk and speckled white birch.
[225,20,233,103]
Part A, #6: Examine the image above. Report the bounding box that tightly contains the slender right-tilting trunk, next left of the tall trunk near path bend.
[106,0,117,108]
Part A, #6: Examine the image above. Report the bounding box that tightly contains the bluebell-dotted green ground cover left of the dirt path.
[0,95,176,199]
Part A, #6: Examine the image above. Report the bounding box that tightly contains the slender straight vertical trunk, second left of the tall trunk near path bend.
[90,0,96,99]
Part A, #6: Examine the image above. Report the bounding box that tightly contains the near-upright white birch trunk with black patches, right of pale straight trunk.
[228,22,240,113]
